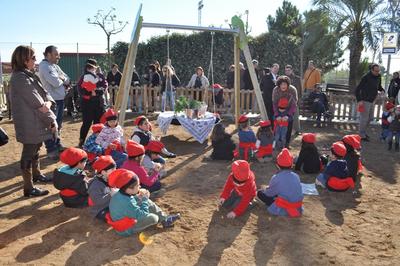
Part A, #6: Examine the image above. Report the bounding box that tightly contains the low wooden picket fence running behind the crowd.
[0,82,384,121]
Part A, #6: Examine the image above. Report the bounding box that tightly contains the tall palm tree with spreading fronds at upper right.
[313,0,388,90]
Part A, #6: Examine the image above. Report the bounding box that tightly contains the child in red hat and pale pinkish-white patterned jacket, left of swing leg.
[96,109,128,168]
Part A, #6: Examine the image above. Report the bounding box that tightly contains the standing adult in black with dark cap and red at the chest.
[78,59,107,147]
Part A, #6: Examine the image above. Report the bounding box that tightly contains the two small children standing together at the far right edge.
[381,101,400,152]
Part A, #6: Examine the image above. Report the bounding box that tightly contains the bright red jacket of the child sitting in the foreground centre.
[220,171,257,216]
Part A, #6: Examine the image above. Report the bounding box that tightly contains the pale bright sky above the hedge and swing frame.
[0,0,400,75]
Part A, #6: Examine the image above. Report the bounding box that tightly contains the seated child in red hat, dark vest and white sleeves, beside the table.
[131,115,176,158]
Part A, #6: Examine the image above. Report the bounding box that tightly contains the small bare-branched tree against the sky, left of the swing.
[87,7,128,68]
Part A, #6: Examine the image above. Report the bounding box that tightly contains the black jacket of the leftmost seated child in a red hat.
[53,169,88,208]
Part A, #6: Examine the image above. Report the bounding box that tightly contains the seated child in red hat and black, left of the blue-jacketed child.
[295,133,322,174]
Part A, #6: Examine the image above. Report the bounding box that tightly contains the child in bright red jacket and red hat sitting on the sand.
[218,160,257,219]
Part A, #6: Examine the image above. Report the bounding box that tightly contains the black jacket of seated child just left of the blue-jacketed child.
[295,147,321,174]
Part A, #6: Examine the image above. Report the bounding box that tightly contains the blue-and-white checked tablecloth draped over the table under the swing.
[157,111,215,143]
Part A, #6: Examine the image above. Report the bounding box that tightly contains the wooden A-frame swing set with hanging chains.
[114,4,268,125]
